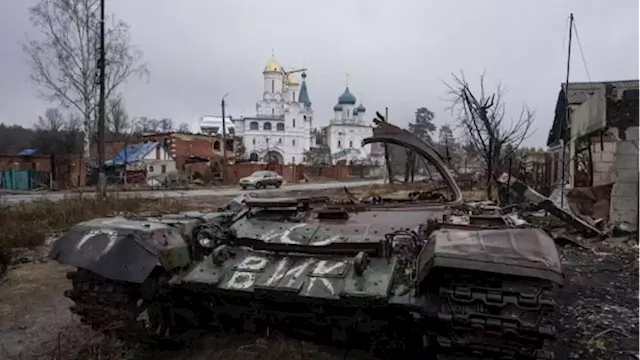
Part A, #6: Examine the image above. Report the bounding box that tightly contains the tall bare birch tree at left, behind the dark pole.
[22,0,148,157]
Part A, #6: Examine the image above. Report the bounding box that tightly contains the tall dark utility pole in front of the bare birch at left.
[98,0,107,199]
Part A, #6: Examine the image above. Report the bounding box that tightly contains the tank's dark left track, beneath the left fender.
[64,269,196,346]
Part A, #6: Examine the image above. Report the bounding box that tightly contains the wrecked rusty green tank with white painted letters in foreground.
[50,123,563,359]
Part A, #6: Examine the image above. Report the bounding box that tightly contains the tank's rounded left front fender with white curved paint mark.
[49,218,191,283]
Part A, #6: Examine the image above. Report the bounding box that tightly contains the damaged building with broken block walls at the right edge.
[547,80,640,224]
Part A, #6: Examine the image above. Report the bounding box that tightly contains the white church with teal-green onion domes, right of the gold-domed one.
[324,86,375,164]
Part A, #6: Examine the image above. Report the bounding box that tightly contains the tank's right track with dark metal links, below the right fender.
[434,273,556,360]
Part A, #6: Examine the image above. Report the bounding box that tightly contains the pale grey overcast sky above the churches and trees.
[0,0,640,146]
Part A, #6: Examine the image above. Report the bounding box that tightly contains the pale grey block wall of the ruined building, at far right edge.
[611,127,640,224]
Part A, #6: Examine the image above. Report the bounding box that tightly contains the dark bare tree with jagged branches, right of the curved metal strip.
[445,74,534,199]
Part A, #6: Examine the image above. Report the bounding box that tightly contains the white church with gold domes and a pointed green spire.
[233,59,313,164]
